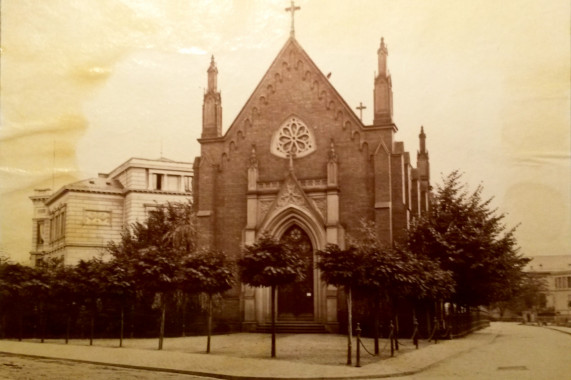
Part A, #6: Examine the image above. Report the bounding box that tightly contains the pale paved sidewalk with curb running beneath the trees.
[0,324,498,379]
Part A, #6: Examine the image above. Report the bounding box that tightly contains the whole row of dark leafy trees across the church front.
[0,172,529,364]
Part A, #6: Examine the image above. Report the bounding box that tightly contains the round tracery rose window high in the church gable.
[271,116,315,158]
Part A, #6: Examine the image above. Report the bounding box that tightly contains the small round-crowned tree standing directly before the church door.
[238,234,306,358]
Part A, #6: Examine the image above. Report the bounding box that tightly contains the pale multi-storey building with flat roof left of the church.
[30,158,193,265]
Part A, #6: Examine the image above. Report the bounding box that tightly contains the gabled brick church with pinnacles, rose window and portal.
[193,33,430,331]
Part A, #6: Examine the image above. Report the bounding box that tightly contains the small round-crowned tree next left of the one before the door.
[182,250,234,353]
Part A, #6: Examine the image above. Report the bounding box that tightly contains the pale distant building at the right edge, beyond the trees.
[525,255,571,319]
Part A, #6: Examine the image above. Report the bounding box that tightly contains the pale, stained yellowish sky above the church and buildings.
[0,0,571,262]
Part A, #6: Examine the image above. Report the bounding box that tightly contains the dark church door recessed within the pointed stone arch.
[278,225,314,321]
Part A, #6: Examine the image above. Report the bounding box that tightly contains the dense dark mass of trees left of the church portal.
[0,203,234,352]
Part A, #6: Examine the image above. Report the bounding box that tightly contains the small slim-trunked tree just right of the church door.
[316,244,366,365]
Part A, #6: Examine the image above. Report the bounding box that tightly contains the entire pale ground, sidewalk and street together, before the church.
[0,322,571,379]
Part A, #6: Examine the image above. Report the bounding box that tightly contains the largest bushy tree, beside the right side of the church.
[407,171,528,306]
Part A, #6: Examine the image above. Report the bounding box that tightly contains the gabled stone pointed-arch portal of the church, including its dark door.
[243,184,338,331]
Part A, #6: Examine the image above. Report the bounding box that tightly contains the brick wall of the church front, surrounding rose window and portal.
[194,40,424,326]
